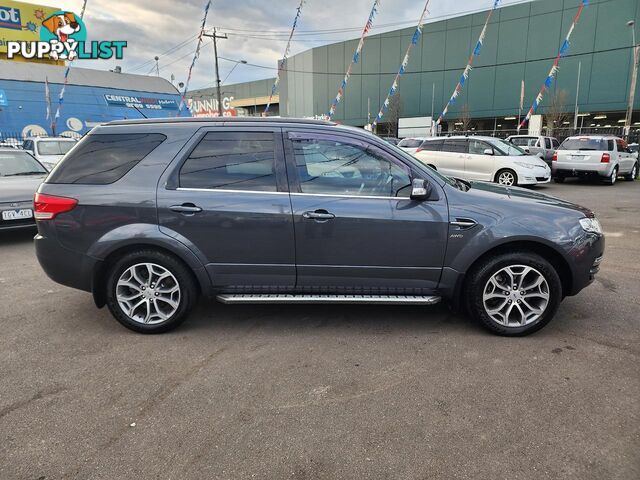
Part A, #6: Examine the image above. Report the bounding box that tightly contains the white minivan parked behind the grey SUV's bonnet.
[414,137,551,186]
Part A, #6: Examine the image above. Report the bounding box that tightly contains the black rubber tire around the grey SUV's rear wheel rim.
[106,249,198,334]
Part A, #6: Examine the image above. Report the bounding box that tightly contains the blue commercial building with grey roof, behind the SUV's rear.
[0,60,185,140]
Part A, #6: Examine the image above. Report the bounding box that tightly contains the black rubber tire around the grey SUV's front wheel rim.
[464,251,563,337]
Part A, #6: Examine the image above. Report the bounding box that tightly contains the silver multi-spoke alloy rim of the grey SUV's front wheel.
[482,265,550,327]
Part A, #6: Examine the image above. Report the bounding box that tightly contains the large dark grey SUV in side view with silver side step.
[34,118,604,335]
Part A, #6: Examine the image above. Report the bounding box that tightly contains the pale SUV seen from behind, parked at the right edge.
[552,135,638,185]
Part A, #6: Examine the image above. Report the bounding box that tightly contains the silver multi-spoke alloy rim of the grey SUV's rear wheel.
[116,263,181,325]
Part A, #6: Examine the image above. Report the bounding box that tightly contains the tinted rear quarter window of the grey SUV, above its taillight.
[47,133,167,185]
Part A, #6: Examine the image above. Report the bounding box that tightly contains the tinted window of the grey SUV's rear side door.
[180,132,277,192]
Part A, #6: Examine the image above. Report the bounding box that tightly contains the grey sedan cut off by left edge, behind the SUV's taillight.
[0,147,47,230]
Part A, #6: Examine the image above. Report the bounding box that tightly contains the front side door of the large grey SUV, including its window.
[285,129,448,294]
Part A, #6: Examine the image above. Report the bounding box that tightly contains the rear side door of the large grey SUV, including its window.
[158,126,295,293]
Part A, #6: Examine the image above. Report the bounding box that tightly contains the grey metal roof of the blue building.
[0,60,179,95]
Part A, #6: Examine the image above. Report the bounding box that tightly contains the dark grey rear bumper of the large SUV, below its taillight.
[34,234,98,292]
